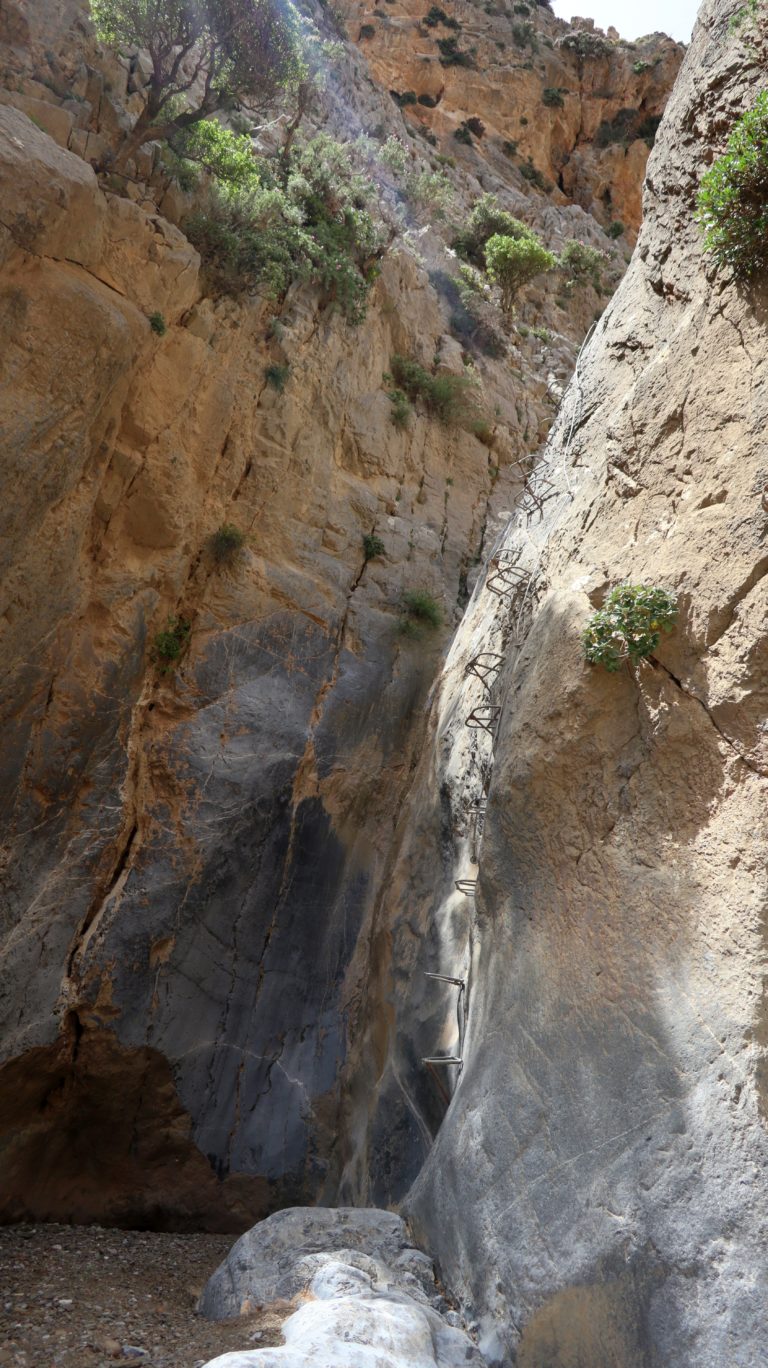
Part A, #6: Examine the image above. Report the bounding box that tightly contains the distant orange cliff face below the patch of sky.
[332,0,683,242]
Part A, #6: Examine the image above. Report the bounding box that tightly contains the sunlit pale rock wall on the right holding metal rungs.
[336,0,768,1368]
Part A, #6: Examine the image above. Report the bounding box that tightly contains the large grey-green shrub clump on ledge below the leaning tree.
[183,134,383,323]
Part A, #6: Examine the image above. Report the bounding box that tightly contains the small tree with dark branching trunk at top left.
[90,0,304,163]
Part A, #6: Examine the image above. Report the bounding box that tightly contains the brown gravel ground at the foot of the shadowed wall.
[0,1226,287,1368]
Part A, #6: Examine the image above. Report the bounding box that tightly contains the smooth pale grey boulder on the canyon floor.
[200,1208,485,1368]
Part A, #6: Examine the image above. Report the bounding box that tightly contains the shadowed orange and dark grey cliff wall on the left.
[0,0,676,1228]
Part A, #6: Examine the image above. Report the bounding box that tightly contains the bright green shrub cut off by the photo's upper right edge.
[695,90,768,280]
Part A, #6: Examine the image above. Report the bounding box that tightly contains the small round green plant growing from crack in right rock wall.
[582,584,678,672]
